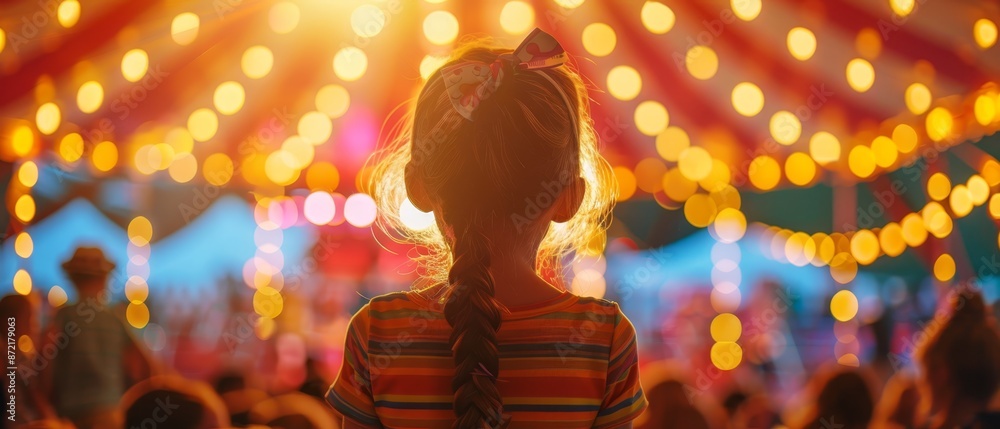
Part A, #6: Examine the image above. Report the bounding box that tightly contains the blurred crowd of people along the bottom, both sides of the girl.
[0,248,1000,429]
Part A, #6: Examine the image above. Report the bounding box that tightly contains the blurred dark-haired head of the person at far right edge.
[918,290,1000,414]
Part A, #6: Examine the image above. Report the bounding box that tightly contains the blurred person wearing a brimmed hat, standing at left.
[43,247,152,429]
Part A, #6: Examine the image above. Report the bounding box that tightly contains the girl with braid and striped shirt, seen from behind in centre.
[327,29,646,429]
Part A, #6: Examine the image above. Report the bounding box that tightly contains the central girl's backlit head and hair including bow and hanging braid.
[372,30,617,427]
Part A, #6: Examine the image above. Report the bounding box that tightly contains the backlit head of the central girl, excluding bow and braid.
[372,27,617,281]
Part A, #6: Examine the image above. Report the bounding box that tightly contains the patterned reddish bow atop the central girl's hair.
[441,28,567,121]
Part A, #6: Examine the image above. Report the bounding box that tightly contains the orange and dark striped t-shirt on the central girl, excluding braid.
[326,288,646,429]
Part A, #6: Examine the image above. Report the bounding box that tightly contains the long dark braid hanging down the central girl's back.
[444,211,504,429]
